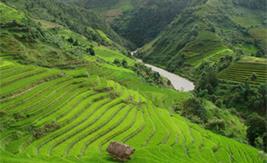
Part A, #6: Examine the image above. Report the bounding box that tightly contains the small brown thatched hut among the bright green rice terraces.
[107,142,135,161]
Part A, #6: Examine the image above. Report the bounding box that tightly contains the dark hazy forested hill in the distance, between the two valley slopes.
[70,0,205,47]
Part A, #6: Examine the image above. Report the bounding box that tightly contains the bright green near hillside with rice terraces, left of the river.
[0,1,264,163]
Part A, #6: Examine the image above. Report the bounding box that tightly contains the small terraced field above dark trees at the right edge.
[219,57,267,84]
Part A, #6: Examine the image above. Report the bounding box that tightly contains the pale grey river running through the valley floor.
[131,51,195,92]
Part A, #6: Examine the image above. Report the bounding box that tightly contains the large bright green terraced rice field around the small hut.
[0,58,262,163]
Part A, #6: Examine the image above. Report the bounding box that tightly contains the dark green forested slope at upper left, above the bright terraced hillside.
[1,0,131,48]
